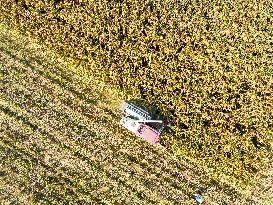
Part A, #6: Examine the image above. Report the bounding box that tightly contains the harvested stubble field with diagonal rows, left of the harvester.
[0,26,268,204]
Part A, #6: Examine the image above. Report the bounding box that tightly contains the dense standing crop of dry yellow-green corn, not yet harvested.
[0,0,273,184]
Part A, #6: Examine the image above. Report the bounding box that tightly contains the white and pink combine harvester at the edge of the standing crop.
[120,102,166,144]
